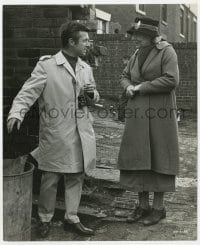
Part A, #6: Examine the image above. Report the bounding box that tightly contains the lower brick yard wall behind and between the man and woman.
[94,34,197,112]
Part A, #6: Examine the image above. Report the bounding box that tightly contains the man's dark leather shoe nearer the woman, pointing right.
[64,221,94,236]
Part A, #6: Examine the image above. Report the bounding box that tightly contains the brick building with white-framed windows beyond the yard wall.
[96,4,197,42]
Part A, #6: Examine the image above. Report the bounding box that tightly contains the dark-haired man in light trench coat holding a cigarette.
[7,22,99,237]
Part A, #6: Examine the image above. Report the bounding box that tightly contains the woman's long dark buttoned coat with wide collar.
[118,41,179,175]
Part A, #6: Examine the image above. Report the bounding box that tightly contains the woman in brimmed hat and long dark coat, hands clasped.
[118,18,179,225]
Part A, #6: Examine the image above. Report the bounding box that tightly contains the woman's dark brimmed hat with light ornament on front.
[127,17,159,38]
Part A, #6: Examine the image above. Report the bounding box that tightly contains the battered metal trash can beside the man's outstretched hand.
[3,157,34,241]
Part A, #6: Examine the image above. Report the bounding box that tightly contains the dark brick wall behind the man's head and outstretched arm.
[3,5,71,87]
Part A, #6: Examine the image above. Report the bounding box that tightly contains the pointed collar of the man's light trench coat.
[55,51,86,79]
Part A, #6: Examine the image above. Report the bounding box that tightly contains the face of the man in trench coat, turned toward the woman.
[73,31,90,56]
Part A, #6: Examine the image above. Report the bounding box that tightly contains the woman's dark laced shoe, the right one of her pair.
[143,208,166,226]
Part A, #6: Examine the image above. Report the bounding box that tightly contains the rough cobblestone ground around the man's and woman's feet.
[32,112,197,241]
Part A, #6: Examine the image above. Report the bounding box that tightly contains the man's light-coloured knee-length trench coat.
[8,51,99,173]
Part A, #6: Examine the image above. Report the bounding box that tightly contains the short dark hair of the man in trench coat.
[60,21,90,47]
